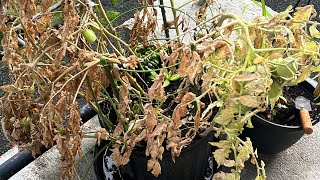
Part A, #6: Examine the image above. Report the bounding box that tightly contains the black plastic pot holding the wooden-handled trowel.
[241,80,320,154]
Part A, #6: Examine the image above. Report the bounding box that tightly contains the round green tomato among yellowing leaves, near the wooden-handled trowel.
[276,59,298,79]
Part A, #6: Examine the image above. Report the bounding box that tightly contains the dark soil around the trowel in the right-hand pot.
[258,86,320,126]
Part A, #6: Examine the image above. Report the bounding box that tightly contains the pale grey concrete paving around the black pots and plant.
[0,0,320,180]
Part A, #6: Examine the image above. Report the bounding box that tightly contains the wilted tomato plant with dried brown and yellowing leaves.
[0,0,320,179]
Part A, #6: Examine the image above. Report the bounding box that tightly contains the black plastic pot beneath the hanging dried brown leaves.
[95,109,217,180]
